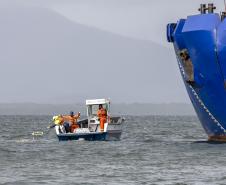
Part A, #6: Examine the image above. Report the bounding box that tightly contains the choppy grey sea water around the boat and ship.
[0,116,226,185]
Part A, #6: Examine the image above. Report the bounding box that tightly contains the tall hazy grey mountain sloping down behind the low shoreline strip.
[0,1,186,104]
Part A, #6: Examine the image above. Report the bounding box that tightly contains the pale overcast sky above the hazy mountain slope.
[51,0,224,46]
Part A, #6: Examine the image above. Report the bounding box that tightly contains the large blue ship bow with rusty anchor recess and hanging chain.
[167,6,226,142]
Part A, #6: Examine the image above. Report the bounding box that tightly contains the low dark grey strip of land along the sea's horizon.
[0,103,195,116]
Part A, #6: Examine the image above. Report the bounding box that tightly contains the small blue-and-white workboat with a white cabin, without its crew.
[55,99,125,141]
